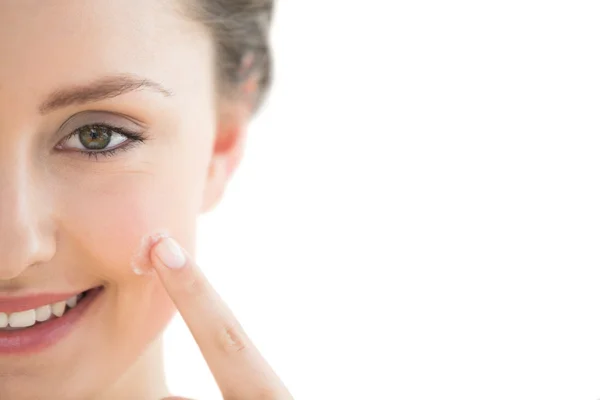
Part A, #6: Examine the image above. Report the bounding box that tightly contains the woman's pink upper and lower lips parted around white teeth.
[0,287,104,356]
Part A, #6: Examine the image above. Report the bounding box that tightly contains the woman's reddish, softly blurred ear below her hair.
[199,76,258,213]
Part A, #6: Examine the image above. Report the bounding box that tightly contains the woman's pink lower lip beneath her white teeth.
[0,287,103,354]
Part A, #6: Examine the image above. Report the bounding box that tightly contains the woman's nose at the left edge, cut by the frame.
[0,152,56,281]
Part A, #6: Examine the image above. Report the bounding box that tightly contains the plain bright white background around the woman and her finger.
[166,0,600,400]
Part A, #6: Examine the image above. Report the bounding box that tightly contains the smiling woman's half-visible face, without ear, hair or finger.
[0,0,224,398]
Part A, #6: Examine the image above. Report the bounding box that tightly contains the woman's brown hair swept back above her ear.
[182,0,274,111]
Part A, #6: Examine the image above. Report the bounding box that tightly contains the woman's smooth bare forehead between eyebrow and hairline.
[0,0,210,112]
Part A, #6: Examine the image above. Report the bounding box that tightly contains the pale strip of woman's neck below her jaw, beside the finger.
[94,335,169,400]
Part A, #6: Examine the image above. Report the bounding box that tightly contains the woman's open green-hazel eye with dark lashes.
[57,124,145,160]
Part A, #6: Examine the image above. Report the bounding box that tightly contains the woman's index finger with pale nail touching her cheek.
[150,237,292,399]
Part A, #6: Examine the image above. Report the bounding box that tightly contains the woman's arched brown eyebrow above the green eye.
[39,74,173,114]
